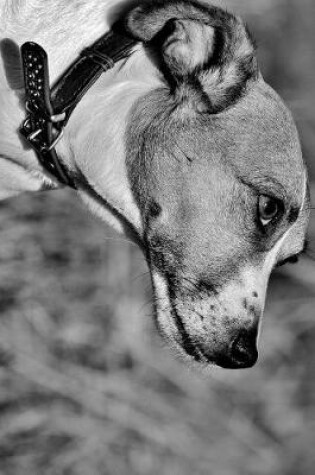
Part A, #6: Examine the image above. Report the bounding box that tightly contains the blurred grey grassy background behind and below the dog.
[0,0,315,475]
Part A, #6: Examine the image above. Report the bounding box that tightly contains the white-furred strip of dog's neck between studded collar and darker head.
[57,46,161,234]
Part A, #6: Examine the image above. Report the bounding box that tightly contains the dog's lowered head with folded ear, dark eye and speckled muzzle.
[121,1,309,368]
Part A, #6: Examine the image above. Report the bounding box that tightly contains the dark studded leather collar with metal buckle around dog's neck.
[20,31,137,188]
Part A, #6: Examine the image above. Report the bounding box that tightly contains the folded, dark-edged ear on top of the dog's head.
[125,0,258,113]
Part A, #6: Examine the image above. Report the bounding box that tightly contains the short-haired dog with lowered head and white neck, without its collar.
[0,0,309,368]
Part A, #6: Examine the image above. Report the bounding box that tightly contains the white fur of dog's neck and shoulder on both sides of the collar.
[0,0,159,234]
